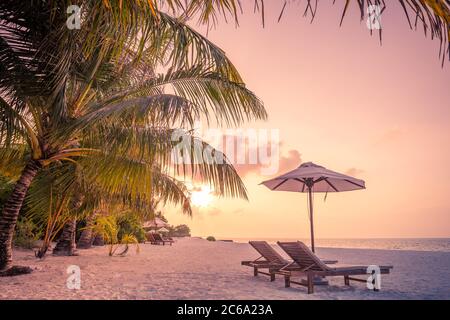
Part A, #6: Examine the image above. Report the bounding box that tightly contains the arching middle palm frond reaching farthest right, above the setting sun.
[66,67,267,138]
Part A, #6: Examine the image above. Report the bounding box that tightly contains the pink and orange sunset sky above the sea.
[163,1,450,239]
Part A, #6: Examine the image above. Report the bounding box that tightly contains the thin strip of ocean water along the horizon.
[230,238,450,252]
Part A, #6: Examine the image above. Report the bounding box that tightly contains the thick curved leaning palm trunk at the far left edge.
[0,160,41,272]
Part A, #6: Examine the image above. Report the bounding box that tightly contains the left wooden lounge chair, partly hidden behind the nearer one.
[241,241,337,281]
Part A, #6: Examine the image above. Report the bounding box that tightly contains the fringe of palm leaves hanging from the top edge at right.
[159,0,450,59]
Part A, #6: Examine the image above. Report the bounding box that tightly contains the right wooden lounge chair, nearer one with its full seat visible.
[277,241,393,293]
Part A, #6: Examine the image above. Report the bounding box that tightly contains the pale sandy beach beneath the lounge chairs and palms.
[0,239,450,299]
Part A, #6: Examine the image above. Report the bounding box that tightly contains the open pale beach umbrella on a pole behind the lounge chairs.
[261,162,366,252]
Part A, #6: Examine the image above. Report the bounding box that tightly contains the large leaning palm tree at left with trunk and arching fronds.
[0,0,266,271]
